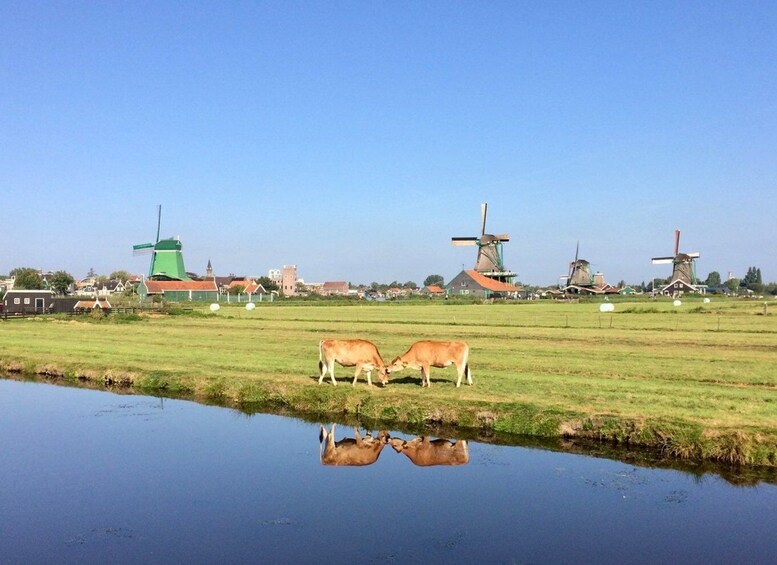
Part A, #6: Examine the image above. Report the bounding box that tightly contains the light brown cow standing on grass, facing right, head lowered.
[318,339,388,386]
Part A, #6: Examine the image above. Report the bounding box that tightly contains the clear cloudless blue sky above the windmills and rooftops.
[0,0,777,284]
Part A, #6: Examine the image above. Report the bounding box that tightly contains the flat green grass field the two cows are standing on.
[0,298,777,466]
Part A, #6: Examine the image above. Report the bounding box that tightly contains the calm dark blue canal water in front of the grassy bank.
[0,379,777,564]
